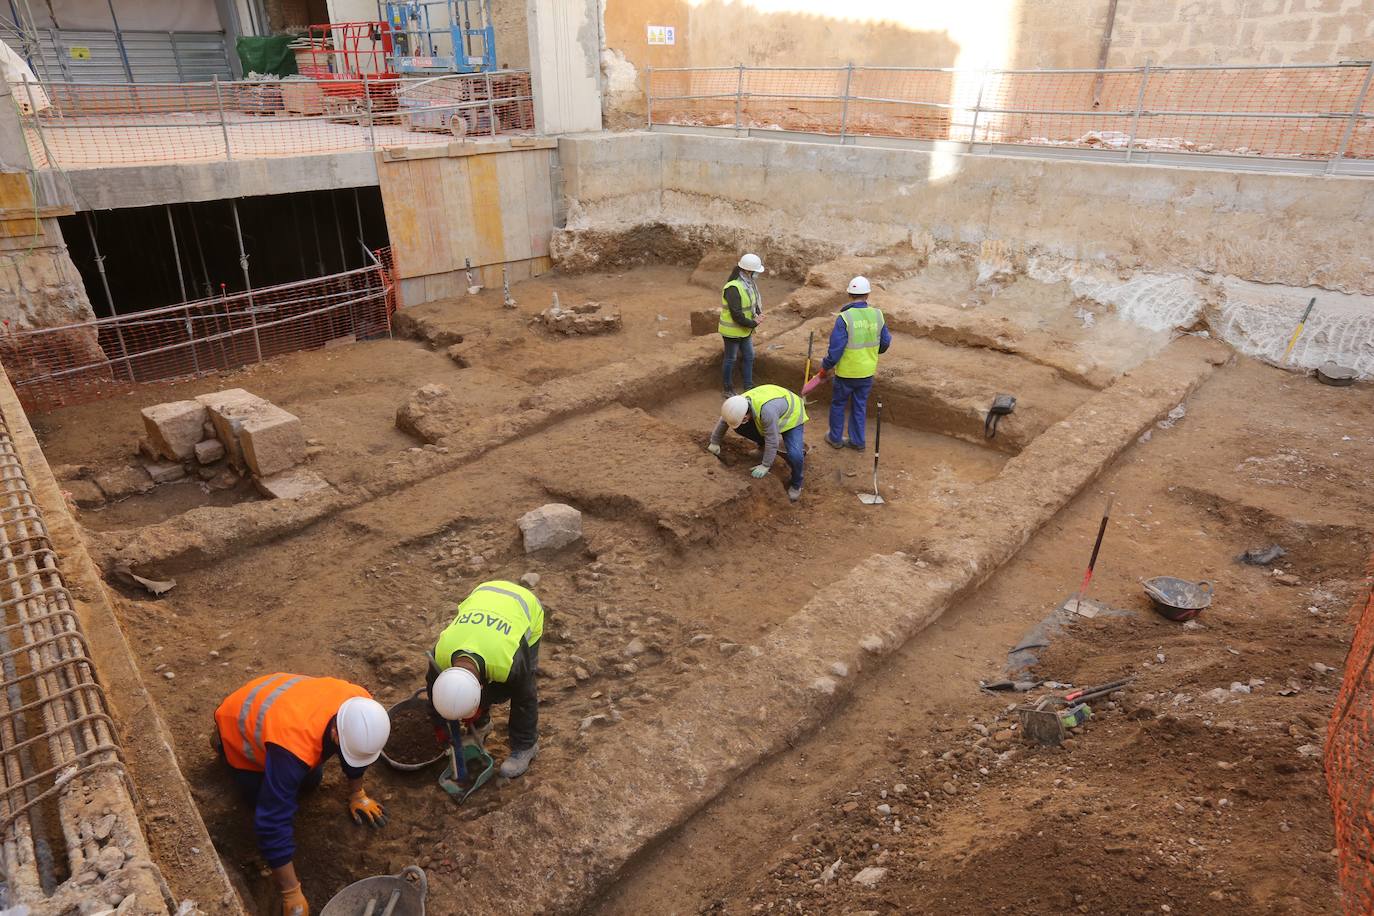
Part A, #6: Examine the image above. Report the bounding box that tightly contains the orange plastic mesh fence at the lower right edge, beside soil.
[1325,558,1374,913]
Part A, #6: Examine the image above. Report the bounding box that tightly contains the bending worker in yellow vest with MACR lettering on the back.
[426,580,544,779]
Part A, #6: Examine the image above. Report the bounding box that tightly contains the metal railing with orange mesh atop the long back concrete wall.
[644,60,1374,170]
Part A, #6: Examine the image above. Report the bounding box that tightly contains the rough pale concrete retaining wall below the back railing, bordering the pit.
[559,133,1374,372]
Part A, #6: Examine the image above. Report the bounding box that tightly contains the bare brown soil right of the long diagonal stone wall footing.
[592,363,1374,913]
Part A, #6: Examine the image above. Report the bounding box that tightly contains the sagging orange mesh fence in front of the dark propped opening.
[0,249,396,412]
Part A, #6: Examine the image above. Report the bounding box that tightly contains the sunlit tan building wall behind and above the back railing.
[602,0,1374,128]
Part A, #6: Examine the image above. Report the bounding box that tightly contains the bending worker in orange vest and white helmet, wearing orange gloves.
[210,673,392,916]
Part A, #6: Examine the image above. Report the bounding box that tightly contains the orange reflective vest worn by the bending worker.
[214,672,371,773]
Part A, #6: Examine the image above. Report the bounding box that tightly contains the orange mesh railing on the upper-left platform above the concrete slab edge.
[21,70,534,169]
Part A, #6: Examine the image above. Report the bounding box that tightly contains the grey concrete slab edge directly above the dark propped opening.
[66,150,376,210]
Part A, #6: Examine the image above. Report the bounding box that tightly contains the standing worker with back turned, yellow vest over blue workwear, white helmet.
[820,276,892,452]
